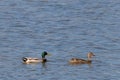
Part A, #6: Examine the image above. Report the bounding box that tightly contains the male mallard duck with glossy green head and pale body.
[22,51,48,63]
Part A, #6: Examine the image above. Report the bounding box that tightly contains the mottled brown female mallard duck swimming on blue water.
[69,52,95,64]
